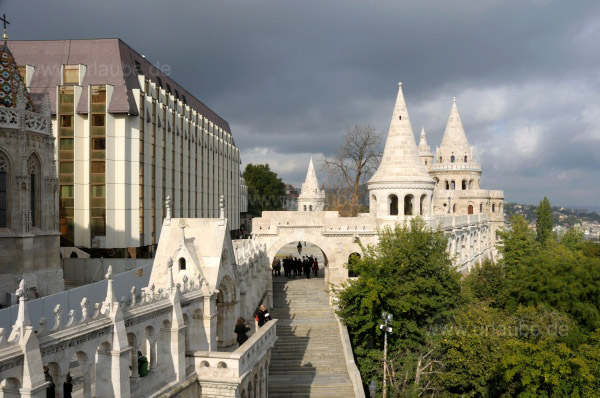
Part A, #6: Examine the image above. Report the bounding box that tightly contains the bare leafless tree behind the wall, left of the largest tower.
[321,124,383,217]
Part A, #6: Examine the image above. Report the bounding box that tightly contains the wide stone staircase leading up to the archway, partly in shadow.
[269,271,354,398]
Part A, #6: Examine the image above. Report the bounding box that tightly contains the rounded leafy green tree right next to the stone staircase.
[336,218,461,388]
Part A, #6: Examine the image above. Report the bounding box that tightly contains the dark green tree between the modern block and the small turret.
[242,163,286,217]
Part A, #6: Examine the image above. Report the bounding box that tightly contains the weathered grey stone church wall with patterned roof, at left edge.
[0,41,64,305]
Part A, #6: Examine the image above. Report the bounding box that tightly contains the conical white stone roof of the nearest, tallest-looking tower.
[369,83,433,184]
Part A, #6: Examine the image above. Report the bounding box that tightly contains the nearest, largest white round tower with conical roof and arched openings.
[367,83,435,219]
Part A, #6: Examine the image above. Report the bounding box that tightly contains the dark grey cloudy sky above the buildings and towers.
[5,0,600,206]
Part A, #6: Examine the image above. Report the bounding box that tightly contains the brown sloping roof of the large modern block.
[9,38,231,132]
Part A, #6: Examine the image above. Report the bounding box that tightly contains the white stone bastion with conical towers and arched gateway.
[252,84,504,284]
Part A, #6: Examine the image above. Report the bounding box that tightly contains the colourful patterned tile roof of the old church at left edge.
[0,41,33,111]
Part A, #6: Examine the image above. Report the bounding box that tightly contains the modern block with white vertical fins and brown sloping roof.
[10,39,246,256]
